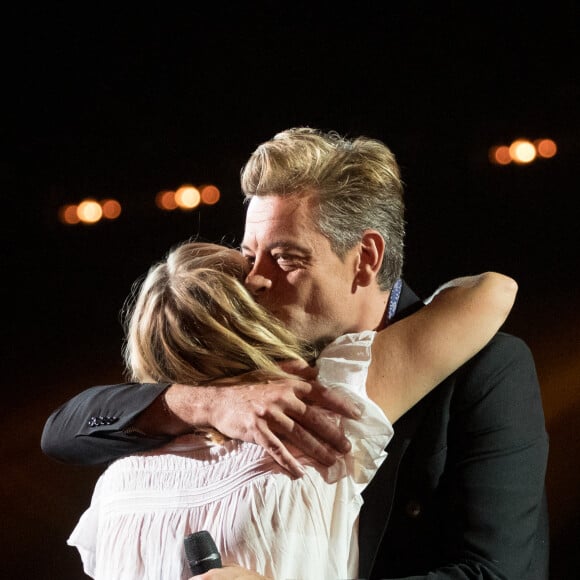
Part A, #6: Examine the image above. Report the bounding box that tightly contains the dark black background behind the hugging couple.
[0,1,580,580]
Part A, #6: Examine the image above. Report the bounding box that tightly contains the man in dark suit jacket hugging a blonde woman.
[43,128,548,579]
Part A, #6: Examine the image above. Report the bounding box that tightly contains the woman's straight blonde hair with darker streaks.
[124,242,308,384]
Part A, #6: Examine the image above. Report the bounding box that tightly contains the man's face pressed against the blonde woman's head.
[242,195,359,344]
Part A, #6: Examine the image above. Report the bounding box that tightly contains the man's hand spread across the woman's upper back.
[162,363,360,477]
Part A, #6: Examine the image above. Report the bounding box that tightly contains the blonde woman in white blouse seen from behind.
[68,243,516,580]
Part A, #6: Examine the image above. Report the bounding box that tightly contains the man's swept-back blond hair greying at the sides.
[241,127,405,290]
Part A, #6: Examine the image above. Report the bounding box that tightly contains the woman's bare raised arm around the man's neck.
[367,272,518,423]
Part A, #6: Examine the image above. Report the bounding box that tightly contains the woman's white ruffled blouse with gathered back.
[67,331,393,580]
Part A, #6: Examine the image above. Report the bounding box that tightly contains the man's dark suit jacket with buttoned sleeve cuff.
[42,286,548,580]
